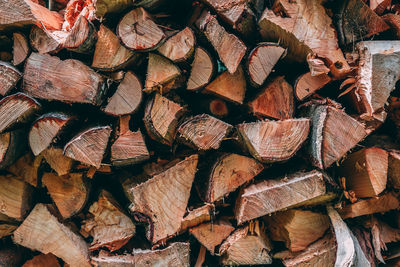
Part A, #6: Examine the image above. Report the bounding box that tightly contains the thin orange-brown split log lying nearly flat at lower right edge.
[338,192,400,219]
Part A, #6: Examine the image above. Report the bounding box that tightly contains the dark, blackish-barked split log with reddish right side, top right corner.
[337,0,389,44]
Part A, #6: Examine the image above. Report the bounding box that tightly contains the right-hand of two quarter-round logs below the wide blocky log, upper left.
[64,126,111,169]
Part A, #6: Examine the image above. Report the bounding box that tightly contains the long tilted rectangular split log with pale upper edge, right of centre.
[235,171,326,224]
